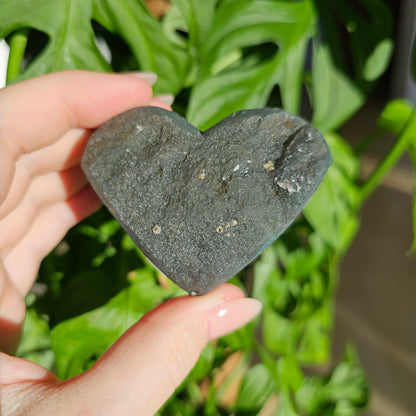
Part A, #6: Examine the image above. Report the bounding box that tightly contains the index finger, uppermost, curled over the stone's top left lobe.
[0,71,152,203]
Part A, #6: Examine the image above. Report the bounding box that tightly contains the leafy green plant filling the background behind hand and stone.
[0,0,416,416]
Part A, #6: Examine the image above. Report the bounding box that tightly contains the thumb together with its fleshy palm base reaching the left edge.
[0,284,261,416]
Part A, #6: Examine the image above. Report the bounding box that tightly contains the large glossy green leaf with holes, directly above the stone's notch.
[187,0,314,130]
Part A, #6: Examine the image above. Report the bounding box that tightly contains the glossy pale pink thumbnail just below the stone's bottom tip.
[209,298,262,339]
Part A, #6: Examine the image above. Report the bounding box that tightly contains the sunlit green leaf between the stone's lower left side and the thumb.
[52,269,177,378]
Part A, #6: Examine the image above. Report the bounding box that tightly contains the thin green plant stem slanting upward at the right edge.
[360,110,416,203]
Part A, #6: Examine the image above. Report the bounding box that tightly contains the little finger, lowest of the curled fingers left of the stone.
[4,185,101,296]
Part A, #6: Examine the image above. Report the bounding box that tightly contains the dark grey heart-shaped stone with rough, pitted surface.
[82,107,331,294]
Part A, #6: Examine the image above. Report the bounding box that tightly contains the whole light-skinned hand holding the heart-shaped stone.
[0,71,260,416]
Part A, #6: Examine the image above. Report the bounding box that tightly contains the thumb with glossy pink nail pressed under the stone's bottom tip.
[57,284,261,416]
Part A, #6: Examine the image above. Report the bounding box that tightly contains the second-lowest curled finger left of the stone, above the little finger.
[0,165,87,256]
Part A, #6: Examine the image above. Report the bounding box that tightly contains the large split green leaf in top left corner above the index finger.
[0,0,189,93]
